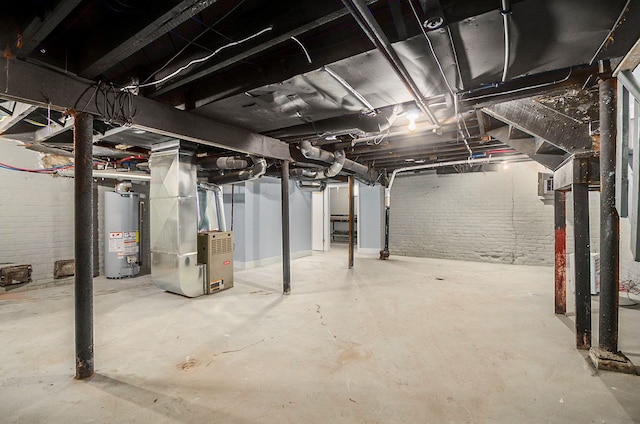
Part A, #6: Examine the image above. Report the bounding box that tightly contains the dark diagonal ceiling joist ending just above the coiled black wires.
[80,0,218,79]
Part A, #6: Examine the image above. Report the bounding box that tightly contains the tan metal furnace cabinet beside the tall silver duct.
[198,231,233,294]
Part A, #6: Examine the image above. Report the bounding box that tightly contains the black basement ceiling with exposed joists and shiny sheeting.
[0,0,640,179]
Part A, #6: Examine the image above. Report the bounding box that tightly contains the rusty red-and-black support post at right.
[554,190,567,315]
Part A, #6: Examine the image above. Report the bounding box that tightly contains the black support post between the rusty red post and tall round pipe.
[571,184,591,349]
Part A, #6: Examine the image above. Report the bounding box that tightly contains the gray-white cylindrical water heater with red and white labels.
[104,184,140,278]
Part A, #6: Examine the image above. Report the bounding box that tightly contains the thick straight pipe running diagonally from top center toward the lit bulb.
[342,0,440,126]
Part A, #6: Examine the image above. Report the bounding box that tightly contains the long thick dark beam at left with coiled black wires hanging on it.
[0,61,291,160]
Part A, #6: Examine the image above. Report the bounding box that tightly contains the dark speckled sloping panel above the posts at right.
[482,99,593,153]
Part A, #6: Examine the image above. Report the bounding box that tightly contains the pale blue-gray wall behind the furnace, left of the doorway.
[223,177,311,268]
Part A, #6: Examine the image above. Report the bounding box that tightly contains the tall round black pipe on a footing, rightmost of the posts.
[598,78,620,353]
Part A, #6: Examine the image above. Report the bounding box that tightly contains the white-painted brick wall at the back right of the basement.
[390,162,554,265]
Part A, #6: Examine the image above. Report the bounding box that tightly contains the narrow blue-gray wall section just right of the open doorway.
[358,184,384,253]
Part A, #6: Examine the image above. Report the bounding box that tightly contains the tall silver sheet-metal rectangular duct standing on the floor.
[149,140,205,297]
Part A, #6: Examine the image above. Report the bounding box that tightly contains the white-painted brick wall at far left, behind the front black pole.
[0,140,74,287]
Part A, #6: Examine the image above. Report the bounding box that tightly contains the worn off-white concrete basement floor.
[0,249,640,424]
